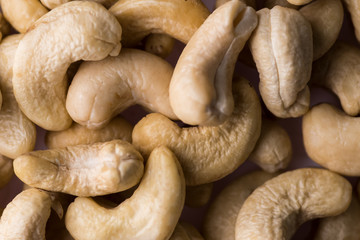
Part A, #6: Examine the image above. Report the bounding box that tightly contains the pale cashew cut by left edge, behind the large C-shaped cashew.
[0,34,36,159]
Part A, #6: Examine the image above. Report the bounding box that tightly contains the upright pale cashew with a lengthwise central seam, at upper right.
[250,6,313,118]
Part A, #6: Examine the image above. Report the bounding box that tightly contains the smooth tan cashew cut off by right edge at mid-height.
[302,103,360,176]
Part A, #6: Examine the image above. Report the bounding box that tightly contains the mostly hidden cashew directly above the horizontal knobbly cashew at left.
[45,117,133,149]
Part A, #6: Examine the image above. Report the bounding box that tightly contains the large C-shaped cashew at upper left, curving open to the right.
[13,1,121,131]
